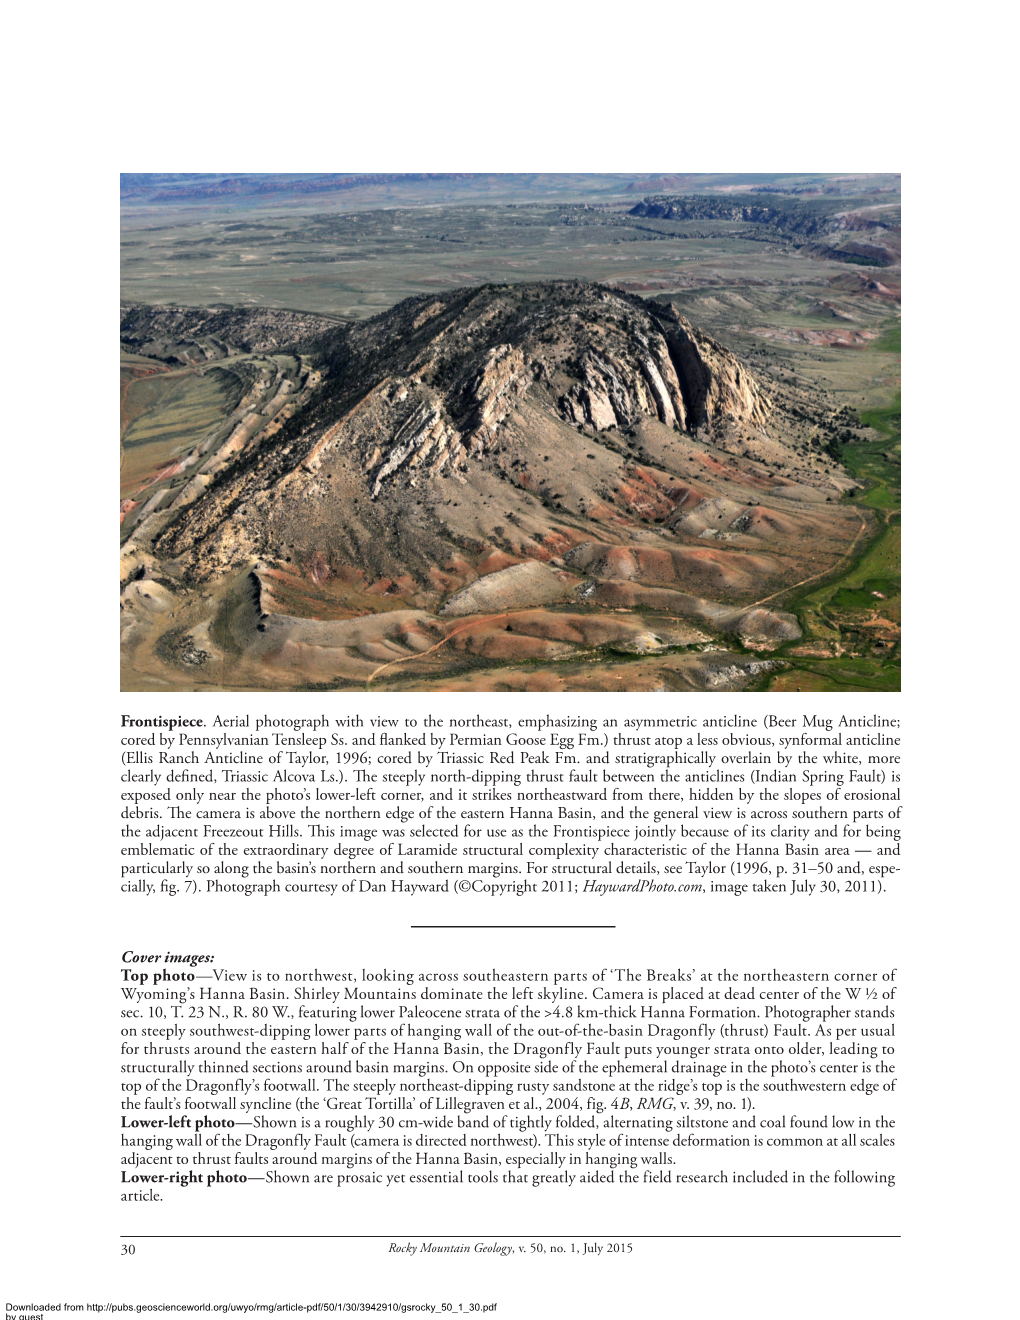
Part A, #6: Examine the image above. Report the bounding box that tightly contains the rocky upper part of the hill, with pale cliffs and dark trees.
[147,285,769,576]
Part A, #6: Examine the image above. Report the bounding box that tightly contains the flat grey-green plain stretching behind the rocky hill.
[121,198,888,319]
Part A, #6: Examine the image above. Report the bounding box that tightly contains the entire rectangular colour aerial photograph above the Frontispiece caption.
[120,173,901,693]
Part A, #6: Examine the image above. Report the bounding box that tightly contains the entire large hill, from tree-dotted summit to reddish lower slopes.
[123,282,862,686]
